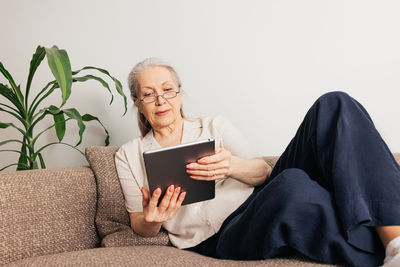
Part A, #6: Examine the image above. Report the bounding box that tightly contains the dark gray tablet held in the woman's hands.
[143,139,215,205]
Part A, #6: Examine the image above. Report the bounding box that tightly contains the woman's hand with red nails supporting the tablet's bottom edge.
[141,185,186,223]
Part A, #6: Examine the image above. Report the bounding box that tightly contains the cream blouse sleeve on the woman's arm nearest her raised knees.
[215,116,259,159]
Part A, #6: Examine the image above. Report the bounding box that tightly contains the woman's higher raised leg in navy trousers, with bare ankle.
[258,92,400,262]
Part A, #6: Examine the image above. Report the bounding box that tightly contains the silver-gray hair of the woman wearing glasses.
[128,57,185,137]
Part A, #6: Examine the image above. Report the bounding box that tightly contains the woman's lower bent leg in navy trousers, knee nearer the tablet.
[195,168,382,266]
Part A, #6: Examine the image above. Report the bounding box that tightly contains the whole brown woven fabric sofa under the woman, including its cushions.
[0,147,400,266]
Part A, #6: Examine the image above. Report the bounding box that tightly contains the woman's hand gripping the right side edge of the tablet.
[186,148,232,181]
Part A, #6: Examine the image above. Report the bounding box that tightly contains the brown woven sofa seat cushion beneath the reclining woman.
[7,245,340,267]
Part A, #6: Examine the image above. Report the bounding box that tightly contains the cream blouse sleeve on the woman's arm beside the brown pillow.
[115,147,143,215]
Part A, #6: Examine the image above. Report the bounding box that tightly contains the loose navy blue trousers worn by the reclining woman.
[189,92,400,266]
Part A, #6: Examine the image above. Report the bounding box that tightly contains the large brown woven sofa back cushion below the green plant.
[0,167,99,265]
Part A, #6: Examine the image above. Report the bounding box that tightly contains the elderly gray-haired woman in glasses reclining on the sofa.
[115,59,400,266]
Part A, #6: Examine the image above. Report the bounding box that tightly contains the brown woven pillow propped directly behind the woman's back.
[85,146,169,247]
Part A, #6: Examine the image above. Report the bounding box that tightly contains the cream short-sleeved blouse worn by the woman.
[115,116,258,249]
